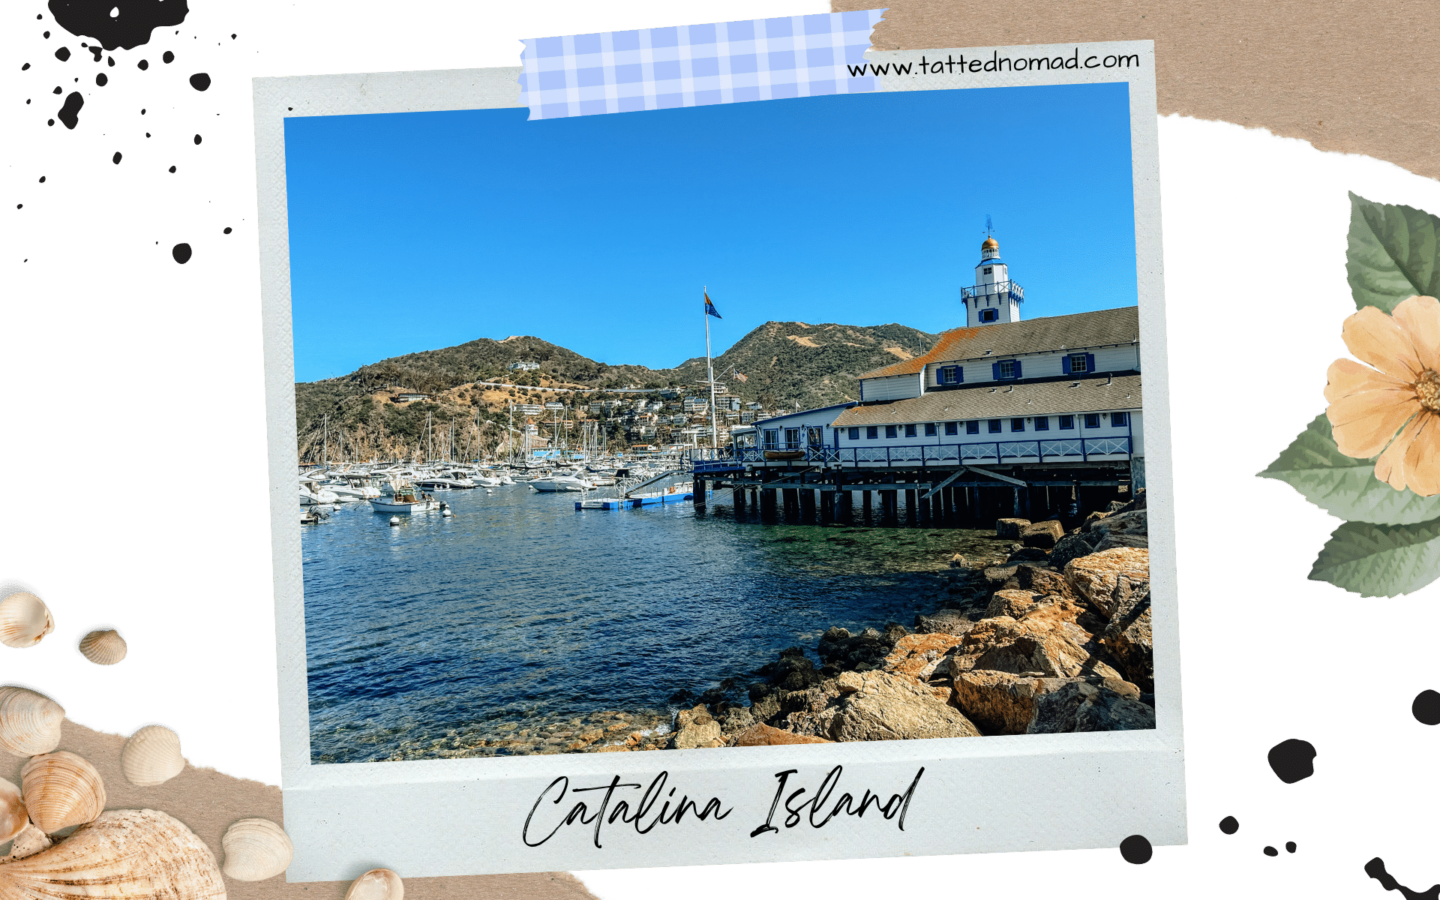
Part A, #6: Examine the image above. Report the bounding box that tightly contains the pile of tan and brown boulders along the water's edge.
[613,490,1155,752]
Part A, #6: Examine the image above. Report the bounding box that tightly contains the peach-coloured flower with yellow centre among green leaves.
[1325,297,1440,497]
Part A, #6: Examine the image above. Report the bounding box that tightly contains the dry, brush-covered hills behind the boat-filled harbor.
[295,323,936,459]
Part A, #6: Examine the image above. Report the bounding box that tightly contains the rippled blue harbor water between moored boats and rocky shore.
[301,485,1008,762]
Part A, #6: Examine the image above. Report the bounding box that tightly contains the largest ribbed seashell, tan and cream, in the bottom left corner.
[0,809,225,900]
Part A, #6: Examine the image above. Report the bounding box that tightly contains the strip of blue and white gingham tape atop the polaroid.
[520,9,884,120]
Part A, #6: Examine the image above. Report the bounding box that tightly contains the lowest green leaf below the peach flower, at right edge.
[1309,518,1440,599]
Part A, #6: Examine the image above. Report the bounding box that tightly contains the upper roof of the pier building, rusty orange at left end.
[860,307,1140,379]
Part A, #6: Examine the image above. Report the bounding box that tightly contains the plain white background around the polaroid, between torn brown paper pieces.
[0,0,1440,899]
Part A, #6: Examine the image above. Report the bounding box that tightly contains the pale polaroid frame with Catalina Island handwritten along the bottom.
[252,29,1188,881]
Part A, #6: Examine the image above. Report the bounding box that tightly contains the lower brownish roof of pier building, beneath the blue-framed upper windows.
[835,374,1140,428]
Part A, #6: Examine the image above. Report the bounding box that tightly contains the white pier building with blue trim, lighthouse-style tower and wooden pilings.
[693,238,1145,521]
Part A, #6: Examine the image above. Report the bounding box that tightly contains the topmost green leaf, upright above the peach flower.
[1345,192,1440,312]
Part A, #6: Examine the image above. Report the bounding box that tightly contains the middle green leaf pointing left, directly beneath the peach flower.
[1256,413,1440,526]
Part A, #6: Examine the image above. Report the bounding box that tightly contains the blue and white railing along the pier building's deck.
[690,435,1130,474]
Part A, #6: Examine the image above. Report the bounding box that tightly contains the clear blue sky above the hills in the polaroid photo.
[285,84,1136,382]
